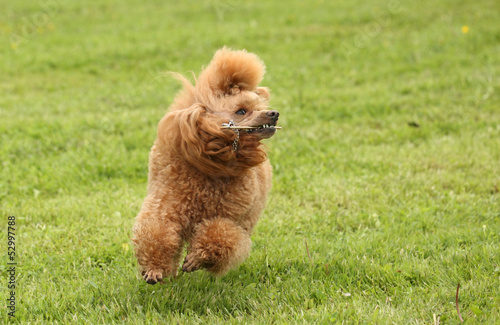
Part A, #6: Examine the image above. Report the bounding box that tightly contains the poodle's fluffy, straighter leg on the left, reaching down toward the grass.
[132,214,183,284]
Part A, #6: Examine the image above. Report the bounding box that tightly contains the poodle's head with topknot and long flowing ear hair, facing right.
[158,48,279,176]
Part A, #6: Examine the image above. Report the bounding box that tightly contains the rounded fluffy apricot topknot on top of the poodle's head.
[197,47,266,95]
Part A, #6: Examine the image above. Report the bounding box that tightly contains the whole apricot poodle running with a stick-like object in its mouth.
[132,47,279,284]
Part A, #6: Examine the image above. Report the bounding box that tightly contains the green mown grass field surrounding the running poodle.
[0,0,500,324]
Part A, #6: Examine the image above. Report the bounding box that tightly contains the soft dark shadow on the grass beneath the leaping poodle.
[111,262,326,318]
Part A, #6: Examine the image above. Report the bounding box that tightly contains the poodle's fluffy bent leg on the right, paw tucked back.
[182,218,252,276]
